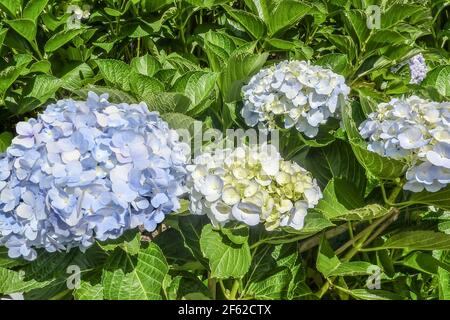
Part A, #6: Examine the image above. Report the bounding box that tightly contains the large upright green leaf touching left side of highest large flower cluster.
[219,53,268,102]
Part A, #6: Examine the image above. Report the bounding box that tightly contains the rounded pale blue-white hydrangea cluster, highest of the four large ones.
[242,60,350,138]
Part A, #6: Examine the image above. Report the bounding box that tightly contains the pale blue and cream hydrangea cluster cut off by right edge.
[360,96,450,192]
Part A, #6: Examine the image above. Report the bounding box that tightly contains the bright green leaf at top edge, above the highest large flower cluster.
[269,0,311,36]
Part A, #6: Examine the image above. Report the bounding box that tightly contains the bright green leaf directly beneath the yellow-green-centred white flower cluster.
[200,225,251,279]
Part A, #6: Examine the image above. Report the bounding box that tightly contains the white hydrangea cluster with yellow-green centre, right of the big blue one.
[187,145,322,230]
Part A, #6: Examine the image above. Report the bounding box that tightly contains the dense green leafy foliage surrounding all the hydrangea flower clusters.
[0,0,450,299]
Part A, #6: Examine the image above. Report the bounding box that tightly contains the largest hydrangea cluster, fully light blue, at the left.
[0,93,188,260]
